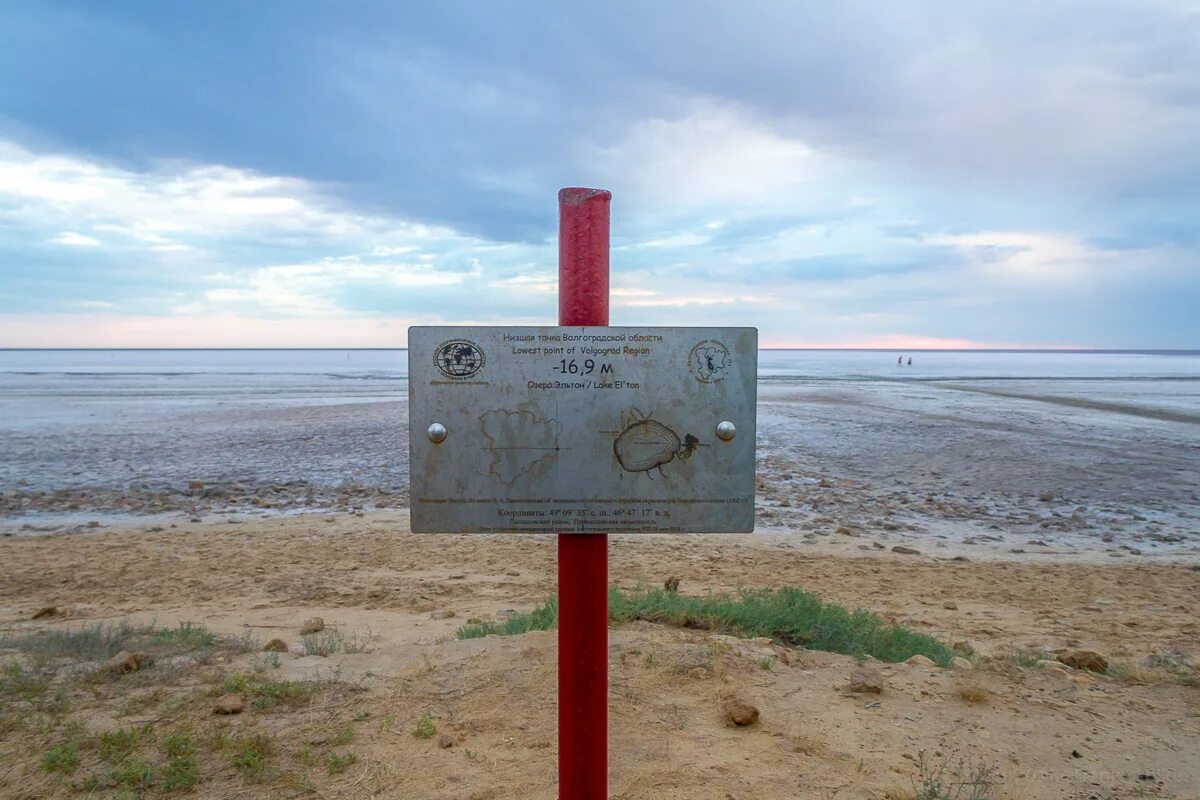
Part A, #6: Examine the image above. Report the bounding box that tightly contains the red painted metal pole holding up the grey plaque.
[558,188,612,800]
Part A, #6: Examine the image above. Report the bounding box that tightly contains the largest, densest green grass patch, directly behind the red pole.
[457,588,955,664]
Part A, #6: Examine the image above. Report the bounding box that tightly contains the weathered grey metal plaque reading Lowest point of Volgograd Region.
[408,326,758,534]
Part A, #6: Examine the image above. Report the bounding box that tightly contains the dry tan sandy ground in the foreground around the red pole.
[0,512,1200,800]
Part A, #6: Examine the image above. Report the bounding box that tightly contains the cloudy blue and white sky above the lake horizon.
[0,0,1200,348]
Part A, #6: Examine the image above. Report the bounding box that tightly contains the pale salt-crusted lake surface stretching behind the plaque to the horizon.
[0,349,1200,561]
